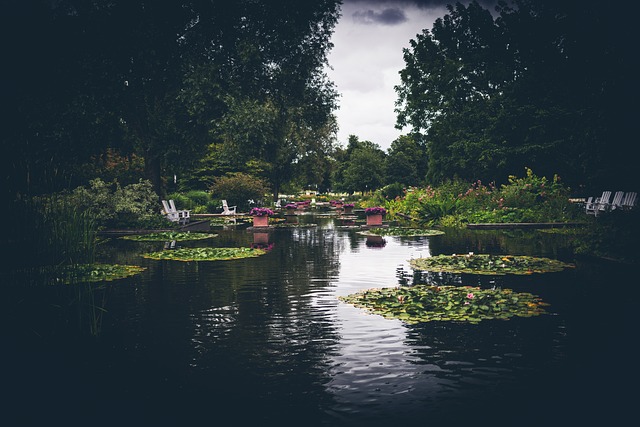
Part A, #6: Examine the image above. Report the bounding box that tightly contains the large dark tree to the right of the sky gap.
[396,0,637,192]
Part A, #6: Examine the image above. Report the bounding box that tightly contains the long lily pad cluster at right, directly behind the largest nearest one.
[409,253,573,275]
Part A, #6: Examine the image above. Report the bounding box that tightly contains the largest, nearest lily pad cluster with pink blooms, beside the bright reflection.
[338,285,548,324]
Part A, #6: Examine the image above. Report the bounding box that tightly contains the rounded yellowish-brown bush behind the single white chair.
[211,173,269,211]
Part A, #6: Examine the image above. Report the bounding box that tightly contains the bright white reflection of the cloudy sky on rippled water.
[326,234,439,416]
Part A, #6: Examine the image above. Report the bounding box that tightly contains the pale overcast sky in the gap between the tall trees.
[327,0,498,151]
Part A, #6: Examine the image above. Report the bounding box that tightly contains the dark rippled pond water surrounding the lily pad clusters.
[0,215,640,426]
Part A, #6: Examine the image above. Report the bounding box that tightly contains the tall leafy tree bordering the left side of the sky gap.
[205,0,338,200]
